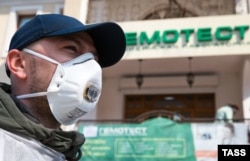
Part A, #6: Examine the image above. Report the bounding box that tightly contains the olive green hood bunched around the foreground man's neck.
[0,84,85,161]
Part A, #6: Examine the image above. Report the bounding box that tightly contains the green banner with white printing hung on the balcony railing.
[78,117,196,161]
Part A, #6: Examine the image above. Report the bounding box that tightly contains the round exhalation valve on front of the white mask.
[84,84,100,102]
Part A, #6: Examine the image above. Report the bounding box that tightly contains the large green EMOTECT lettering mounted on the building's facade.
[125,25,249,46]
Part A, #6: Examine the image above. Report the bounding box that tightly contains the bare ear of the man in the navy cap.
[6,49,27,79]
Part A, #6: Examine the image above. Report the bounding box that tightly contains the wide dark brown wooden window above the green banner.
[125,93,215,119]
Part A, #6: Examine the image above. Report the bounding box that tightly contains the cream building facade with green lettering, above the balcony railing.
[0,0,250,120]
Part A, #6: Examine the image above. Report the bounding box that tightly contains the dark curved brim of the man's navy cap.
[47,22,126,67]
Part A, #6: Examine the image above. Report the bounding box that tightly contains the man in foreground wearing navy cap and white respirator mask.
[0,14,126,161]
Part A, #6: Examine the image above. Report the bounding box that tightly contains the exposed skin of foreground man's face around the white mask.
[24,33,98,127]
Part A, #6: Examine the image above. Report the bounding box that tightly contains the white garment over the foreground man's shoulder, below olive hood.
[0,129,65,161]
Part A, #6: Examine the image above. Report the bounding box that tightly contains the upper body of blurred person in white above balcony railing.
[215,104,239,123]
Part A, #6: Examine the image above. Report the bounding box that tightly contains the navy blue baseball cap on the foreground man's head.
[7,14,126,74]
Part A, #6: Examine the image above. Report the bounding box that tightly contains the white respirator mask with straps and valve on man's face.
[17,48,102,125]
